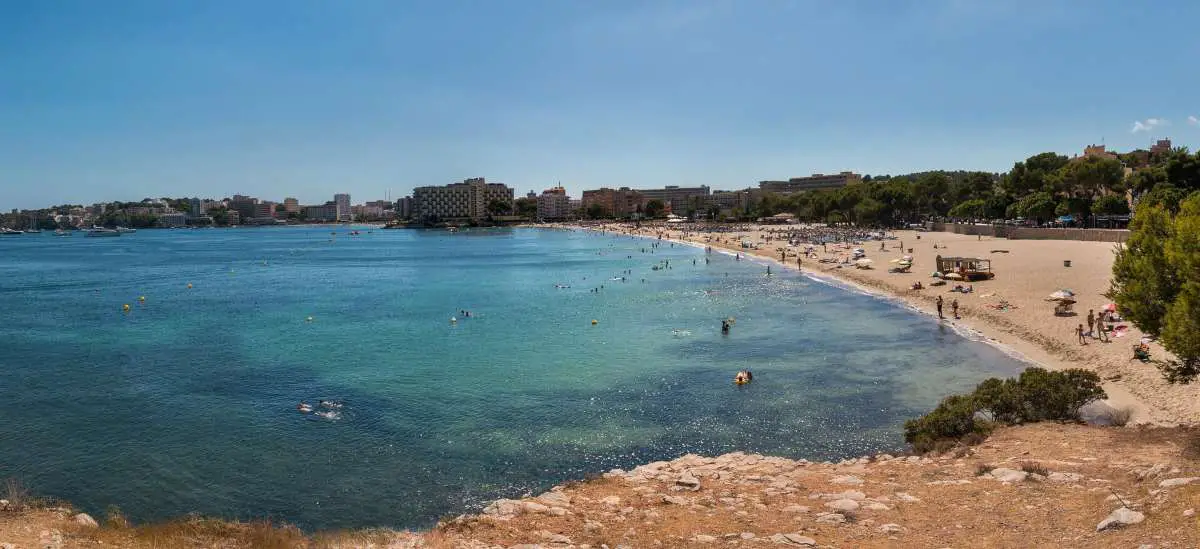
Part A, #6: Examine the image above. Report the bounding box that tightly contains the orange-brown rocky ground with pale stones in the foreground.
[0,423,1200,549]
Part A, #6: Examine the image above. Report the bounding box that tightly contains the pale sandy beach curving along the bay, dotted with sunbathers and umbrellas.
[573,223,1200,426]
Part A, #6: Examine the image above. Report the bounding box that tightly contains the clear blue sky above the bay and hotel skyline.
[0,0,1200,209]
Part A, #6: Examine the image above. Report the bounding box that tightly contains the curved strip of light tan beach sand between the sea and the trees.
[559,223,1200,426]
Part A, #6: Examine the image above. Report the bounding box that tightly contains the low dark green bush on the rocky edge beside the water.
[904,368,1106,453]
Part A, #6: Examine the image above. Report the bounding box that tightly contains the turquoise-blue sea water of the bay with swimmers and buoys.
[0,228,1021,529]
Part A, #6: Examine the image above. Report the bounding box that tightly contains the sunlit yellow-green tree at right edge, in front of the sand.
[1109,192,1200,382]
